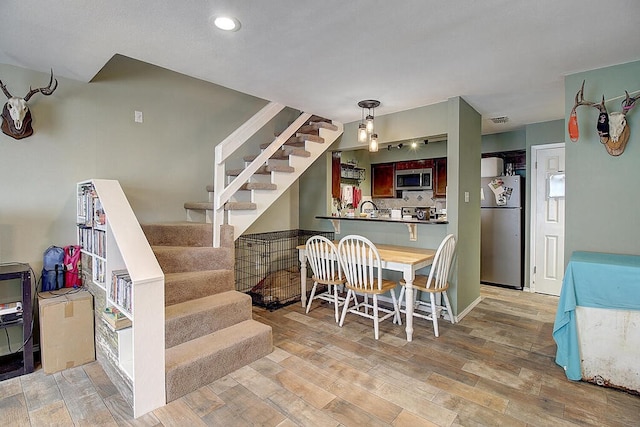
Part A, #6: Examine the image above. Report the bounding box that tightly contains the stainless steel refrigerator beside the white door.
[480,175,524,289]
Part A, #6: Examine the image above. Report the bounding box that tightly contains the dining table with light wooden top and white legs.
[297,242,436,341]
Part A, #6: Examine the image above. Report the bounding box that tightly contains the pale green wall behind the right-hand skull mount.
[565,61,640,262]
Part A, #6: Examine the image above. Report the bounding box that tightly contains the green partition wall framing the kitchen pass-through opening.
[300,97,481,313]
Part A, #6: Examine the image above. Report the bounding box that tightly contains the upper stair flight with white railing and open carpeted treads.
[184,103,343,247]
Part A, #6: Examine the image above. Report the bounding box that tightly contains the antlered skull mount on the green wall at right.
[568,80,638,156]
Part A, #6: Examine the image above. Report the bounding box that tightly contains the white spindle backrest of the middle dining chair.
[338,234,382,291]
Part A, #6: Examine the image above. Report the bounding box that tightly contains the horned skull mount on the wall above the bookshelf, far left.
[0,70,58,139]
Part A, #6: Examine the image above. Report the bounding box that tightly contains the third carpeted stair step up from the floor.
[164,270,236,306]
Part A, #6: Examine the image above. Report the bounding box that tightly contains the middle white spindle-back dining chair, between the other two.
[338,235,400,339]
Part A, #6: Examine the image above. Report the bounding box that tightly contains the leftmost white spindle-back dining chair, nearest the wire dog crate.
[305,236,345,323]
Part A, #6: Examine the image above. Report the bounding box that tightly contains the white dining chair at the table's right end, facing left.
[398,234,456,337]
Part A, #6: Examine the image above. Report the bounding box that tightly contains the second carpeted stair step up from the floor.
[165,290,252,348]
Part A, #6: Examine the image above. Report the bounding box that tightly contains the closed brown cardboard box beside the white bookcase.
[38,290,96,374]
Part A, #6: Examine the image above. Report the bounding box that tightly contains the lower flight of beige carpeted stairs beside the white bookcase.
[142,222,273,402]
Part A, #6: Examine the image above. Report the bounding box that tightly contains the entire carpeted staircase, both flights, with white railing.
[142,103,342,402]
